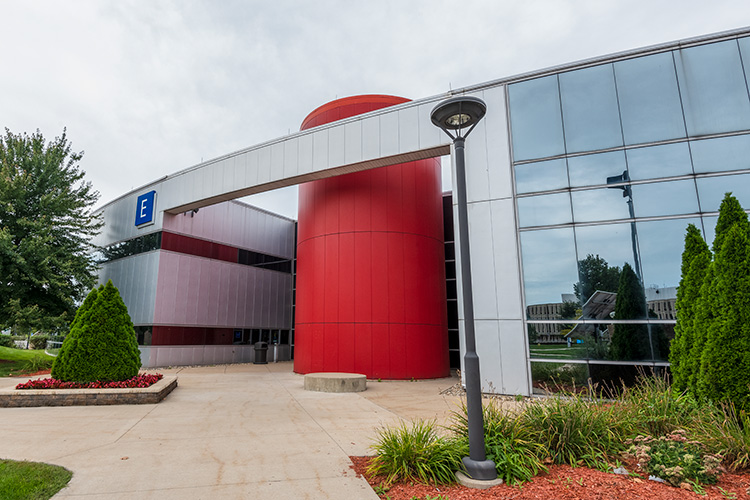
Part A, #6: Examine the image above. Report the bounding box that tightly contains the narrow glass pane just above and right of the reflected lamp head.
[626,142,693,181]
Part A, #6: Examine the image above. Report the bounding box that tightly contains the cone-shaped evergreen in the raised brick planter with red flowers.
[52,280,141,382]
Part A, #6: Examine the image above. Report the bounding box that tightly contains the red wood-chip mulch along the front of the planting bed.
[350,457,750,500]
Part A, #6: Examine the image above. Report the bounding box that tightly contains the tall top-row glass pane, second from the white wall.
[560,64,622,153]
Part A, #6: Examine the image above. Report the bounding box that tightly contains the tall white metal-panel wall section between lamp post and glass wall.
[453,86,531,395]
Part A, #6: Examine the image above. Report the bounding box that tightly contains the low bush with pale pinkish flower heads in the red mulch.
[628,429,722,486]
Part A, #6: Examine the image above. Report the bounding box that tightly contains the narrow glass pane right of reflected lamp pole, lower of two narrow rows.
[632,179,699,217]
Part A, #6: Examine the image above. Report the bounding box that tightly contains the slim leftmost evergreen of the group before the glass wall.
[669,224,711,391]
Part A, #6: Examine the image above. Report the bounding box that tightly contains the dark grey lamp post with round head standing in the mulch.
[430,96,497,481]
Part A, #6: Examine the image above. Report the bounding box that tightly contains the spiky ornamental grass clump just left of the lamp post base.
[368,420,466,484]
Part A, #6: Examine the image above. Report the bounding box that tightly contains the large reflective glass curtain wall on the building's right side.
[508,38,750,387]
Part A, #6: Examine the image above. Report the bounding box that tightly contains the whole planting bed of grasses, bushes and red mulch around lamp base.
[362,375,750,500]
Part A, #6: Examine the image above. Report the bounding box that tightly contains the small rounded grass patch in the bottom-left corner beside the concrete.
[0,460,73,500]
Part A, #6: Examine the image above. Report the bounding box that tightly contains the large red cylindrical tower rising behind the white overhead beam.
[294,95,449,379]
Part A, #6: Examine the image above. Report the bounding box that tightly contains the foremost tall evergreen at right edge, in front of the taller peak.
[698,223,750,409]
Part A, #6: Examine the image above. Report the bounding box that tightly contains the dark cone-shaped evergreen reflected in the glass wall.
[609,263,650,360]
